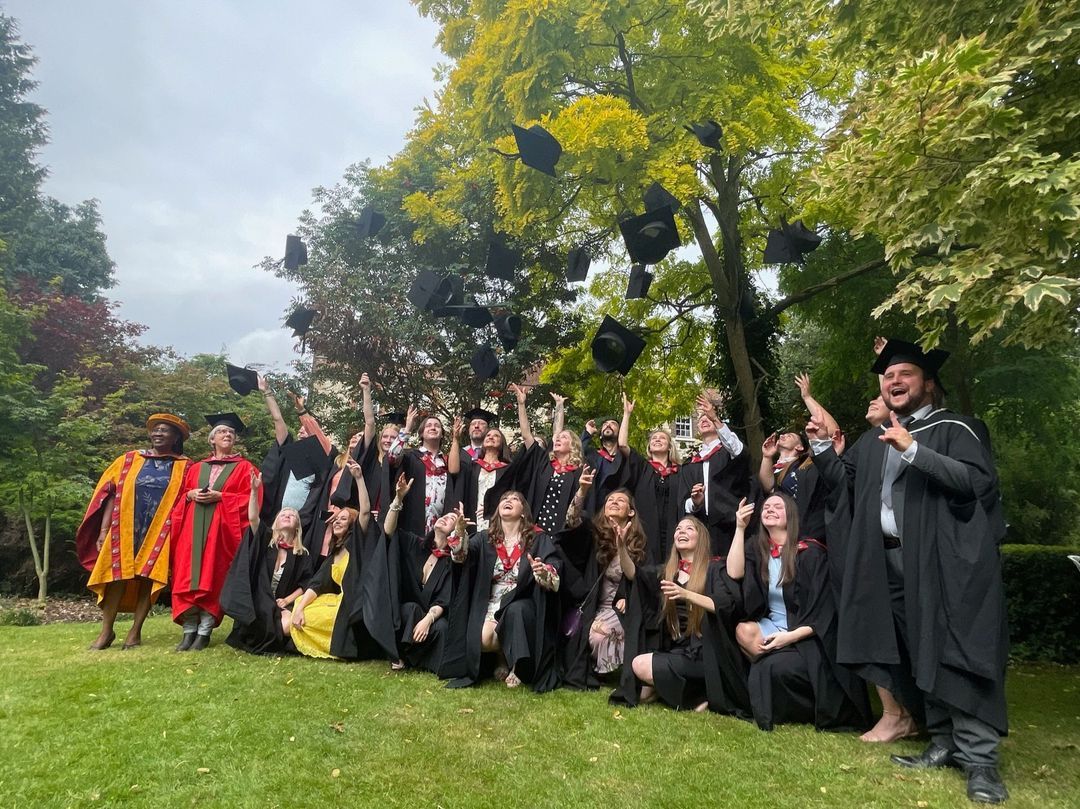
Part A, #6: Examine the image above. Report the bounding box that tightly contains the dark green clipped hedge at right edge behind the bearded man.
[1001,545,1080,663]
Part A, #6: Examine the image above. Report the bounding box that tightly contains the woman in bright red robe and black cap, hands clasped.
[173,413,256,651]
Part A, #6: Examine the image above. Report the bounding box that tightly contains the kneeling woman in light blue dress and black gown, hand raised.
[727,494,872,730]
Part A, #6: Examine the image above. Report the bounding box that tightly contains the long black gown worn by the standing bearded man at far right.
[814,409,1009,734]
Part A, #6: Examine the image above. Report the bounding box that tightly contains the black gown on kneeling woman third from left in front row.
[389,531,454,675]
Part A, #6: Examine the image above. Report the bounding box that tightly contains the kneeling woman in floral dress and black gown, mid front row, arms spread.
[448,491,562,692]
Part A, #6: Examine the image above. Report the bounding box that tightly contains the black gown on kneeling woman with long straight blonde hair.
[610,561,751,719]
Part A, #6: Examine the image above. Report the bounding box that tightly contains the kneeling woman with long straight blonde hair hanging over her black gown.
[611,516,750,718]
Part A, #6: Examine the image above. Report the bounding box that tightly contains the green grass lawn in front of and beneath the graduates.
[0,616,1080,809]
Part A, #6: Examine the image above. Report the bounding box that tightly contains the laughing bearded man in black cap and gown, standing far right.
[807,340,1009,804]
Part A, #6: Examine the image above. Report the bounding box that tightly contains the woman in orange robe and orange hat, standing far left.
[76,413,191,650]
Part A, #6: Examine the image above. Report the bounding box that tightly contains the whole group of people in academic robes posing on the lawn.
[78,340,1008,803]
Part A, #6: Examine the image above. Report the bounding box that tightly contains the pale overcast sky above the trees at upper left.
[0,0,438,367]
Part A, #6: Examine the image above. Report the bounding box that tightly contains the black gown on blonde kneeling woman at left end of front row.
[220,523,312,655]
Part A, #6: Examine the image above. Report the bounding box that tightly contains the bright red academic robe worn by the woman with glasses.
[173,455,262,625]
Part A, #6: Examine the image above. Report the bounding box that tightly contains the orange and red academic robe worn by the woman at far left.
[75,451,190,612]
